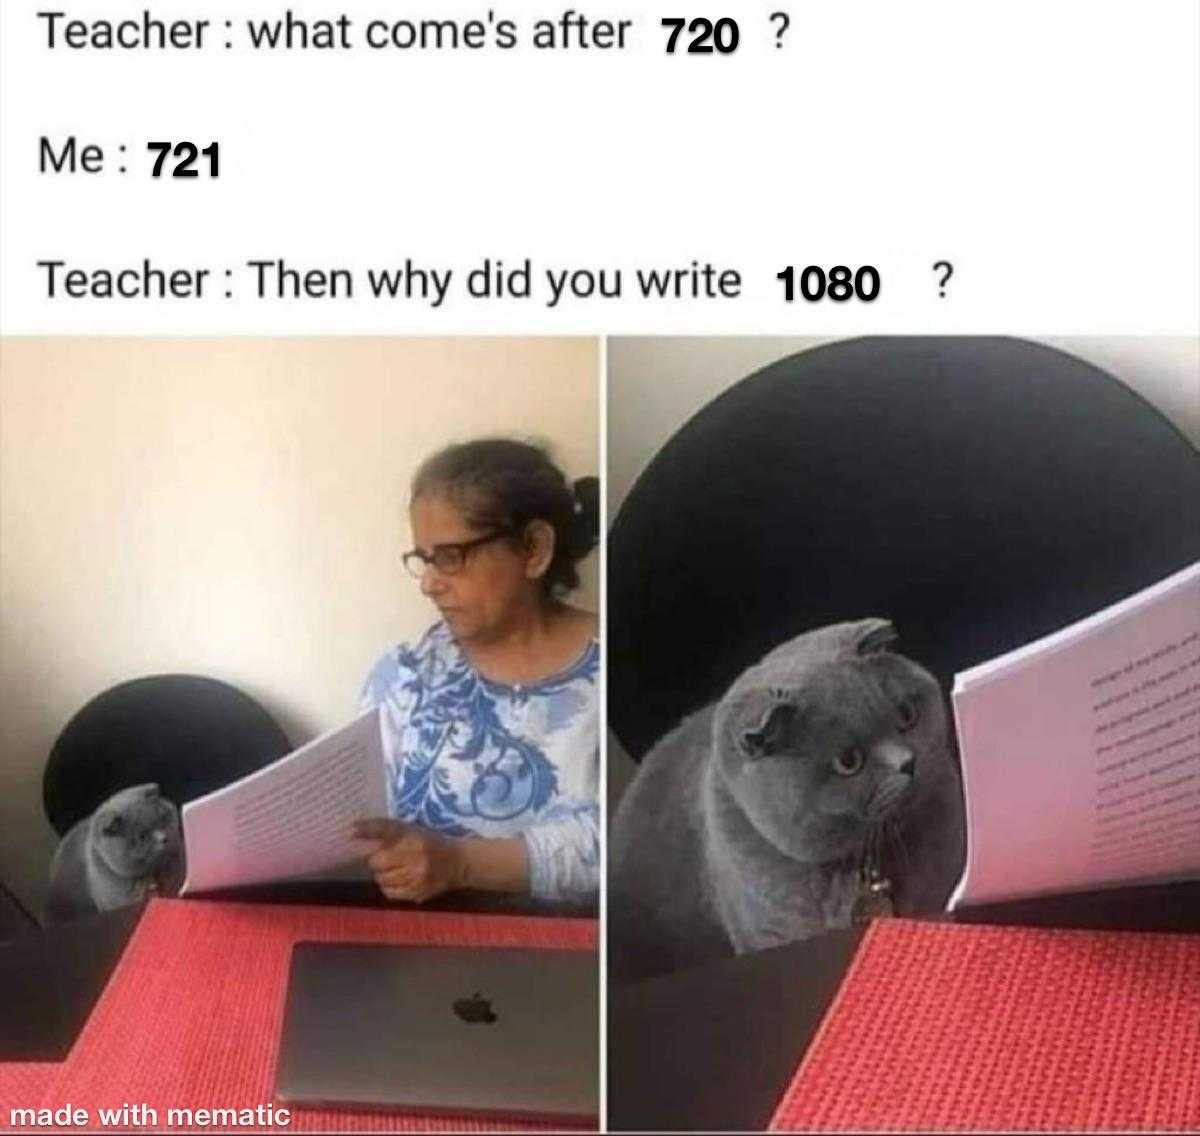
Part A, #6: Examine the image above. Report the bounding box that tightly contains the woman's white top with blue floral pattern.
[362,623,600,901]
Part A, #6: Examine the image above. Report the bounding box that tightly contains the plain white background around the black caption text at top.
[0,0,1200,335]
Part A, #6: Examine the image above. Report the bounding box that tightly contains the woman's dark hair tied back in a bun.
[413,438,600,595]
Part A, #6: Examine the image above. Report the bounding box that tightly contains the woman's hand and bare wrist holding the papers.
[354,817,529,903]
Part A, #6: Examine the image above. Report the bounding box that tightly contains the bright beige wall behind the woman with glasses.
[0,338,599,906]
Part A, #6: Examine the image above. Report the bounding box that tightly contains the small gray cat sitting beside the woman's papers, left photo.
[46,785,184,924]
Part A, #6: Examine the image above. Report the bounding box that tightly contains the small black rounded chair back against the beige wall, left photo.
[42,674,292,835]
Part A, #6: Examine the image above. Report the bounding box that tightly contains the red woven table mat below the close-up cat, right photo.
[770,919,1200,1132]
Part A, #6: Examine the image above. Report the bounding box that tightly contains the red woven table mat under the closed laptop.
[28,900,598,1132]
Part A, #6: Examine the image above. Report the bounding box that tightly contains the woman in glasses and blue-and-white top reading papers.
[356,439,600,902]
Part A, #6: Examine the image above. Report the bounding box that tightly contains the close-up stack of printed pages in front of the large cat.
[949,564,1200,909]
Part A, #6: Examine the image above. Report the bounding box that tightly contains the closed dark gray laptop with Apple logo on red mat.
[276,943,600,1122]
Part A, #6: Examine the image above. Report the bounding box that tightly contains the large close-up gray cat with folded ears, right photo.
[608,619,964,980]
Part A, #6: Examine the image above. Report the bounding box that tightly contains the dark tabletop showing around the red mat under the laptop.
[0,880,595,1062]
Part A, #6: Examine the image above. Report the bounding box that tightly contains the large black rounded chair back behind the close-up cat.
[608,338,1200,759]
